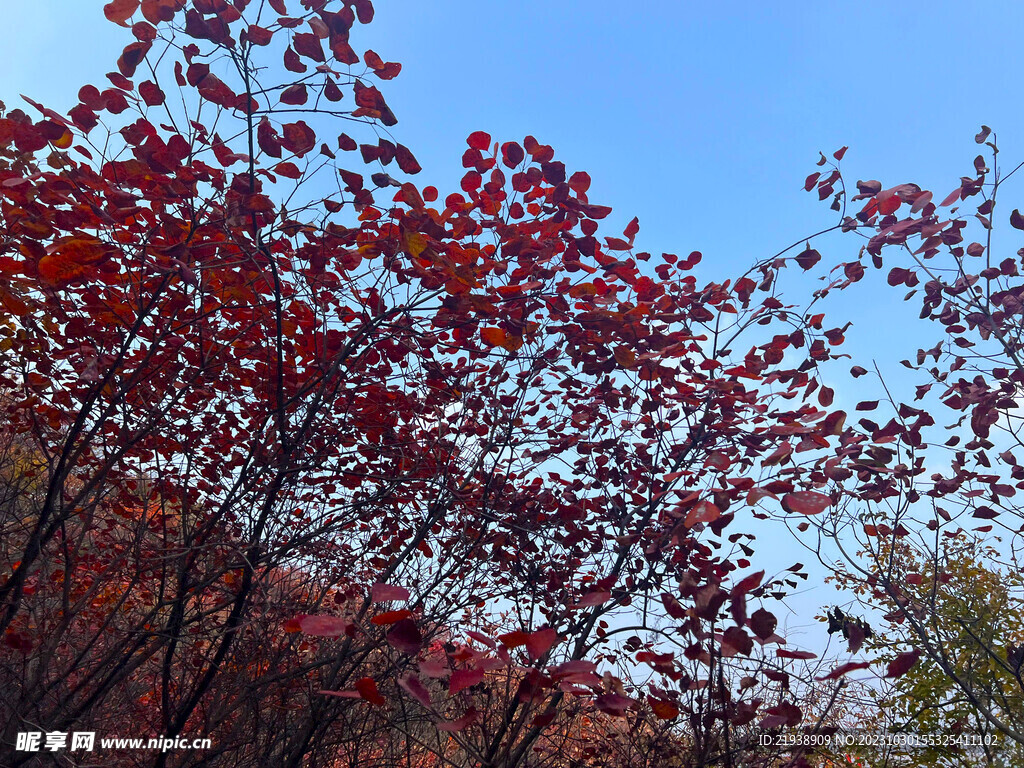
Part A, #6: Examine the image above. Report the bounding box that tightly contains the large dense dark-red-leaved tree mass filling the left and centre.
[0,0,864,766]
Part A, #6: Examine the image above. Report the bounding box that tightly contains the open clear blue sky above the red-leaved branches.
[0,0,1024,655]
